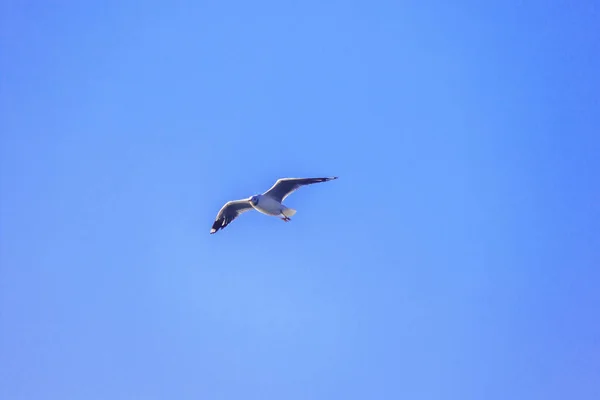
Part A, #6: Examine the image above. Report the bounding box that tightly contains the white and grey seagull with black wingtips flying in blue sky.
[210,176,338,235]
